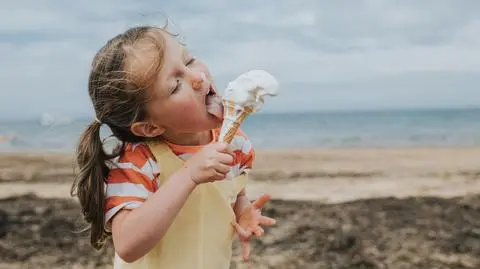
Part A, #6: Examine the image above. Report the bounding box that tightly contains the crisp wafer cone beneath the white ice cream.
[219,101,253,143]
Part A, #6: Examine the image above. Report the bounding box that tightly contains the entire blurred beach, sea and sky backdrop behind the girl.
[0,0,480,269]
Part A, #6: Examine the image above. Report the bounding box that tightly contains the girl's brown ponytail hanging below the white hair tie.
[71,121,110,249]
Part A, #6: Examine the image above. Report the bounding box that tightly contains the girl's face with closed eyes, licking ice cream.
[139,31,222,134]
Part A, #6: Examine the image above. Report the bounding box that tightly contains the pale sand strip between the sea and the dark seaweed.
[0,148,480,203]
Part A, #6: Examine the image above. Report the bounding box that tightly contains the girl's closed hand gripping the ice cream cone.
[185,142,233,184]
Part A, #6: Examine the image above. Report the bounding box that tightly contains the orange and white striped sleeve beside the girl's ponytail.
[105,143,160,223]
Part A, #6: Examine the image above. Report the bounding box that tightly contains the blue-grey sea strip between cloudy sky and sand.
[0,109,480,152]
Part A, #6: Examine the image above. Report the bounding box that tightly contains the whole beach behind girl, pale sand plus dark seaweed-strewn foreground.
[0,148,480,269]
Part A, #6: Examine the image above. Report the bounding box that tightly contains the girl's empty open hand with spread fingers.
[233,194,276,260]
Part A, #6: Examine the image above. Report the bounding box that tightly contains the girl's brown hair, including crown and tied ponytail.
[71,26,167,249]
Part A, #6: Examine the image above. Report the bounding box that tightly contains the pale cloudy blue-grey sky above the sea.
[0,0,480,119]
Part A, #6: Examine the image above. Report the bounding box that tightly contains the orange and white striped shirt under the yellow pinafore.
[105,129,255,222]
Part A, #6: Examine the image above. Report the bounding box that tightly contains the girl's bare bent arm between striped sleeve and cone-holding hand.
[112,169,195,262]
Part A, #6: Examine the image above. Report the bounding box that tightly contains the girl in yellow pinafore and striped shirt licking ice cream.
[72,24,275,269]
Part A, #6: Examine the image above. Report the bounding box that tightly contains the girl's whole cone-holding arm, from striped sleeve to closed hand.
[106,143,233,262]
